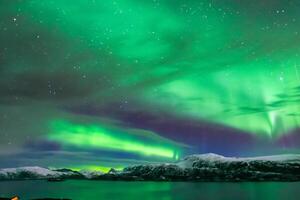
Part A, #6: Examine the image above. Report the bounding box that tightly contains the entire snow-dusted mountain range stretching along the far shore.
[0,153,300,181]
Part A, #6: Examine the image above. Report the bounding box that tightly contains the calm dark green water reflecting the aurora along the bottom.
[0,180,300,200]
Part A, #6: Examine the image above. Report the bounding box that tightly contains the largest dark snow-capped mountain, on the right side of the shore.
[123,153,300,181]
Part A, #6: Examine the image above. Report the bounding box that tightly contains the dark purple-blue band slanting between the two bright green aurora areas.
[67,103,260,155]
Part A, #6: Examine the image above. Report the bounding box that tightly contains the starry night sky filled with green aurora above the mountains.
[0,0,300,171]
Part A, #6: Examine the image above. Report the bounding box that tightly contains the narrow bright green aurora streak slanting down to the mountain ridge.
[48,121,178,159]
